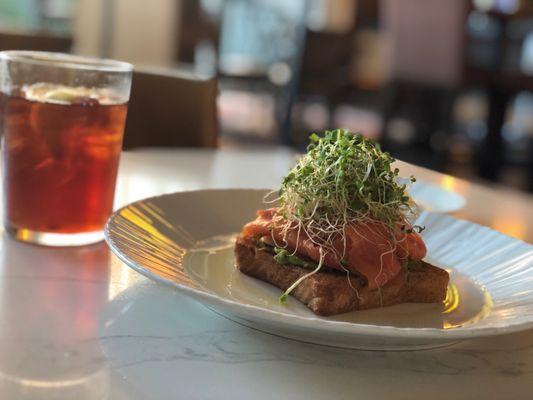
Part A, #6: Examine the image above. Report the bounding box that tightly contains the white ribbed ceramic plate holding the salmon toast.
[106,189,533,349]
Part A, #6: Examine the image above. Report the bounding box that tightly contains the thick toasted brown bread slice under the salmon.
[235,236,449,316]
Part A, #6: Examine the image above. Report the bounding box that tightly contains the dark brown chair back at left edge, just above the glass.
[0,32,72,53]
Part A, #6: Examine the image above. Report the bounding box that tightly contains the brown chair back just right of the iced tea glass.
[123,68,218,149]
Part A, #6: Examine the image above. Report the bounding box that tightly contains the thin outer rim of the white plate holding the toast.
[104,188,533,340]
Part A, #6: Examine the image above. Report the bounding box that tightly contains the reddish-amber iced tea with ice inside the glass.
[0,83,127,234]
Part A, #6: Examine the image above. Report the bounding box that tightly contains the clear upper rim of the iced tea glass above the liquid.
[0,50,133,72]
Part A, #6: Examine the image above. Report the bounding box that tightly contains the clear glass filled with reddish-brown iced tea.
[0,51,132,246]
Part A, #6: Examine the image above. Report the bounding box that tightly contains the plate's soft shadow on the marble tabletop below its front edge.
[100,284,533,376]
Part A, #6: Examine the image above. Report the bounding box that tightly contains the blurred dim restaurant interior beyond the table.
[0,0,533,191]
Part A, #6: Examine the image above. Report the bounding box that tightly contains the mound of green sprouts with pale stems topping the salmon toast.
[266,129,421,303]
